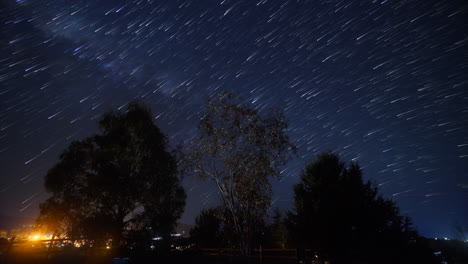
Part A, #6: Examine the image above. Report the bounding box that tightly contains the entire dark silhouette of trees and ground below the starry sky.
[0,93,467,264]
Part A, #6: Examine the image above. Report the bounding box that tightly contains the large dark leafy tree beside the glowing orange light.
[38,103,186,249]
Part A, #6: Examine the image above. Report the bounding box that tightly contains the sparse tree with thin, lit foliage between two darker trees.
[187,92,295,254]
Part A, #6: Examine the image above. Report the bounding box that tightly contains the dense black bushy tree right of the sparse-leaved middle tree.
[288,152,436,263]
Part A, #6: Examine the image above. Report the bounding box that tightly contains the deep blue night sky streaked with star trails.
[0,0,468,237]
